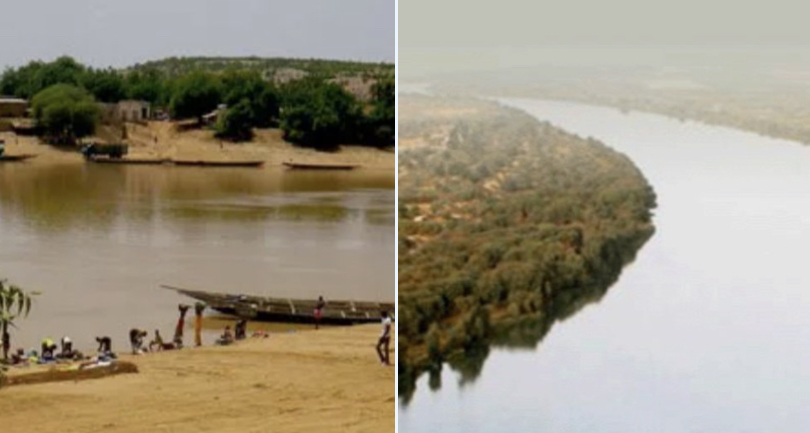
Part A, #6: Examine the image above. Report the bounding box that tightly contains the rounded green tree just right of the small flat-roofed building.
[169,72,221,123]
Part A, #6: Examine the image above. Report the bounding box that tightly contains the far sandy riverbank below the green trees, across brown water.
[0,122,396,173]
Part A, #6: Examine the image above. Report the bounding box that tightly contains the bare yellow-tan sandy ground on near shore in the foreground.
[0,325,396,433]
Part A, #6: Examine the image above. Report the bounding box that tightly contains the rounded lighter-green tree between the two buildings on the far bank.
[32,84,100,144]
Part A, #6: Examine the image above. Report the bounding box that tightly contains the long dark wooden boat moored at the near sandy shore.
[162,285,396,325]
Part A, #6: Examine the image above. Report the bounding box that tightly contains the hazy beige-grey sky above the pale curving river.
[399,0,810,75]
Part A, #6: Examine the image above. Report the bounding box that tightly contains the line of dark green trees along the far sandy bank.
[0,57,395,150]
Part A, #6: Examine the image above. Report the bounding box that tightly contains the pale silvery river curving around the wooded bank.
[399,99,810,433]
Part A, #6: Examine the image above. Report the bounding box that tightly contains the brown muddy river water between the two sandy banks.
[0,162,396,350]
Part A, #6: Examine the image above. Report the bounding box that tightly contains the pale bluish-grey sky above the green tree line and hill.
[0,0,396,68]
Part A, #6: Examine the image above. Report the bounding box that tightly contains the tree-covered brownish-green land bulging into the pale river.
[398,97,655,398]
